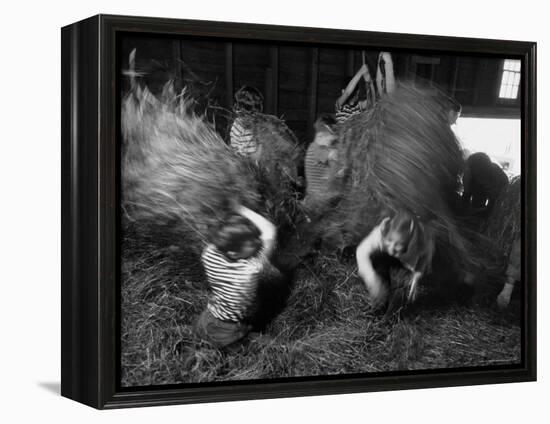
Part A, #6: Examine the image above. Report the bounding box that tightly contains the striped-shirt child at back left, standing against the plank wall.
[229,85,264,157]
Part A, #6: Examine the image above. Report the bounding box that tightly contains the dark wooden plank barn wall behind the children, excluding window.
[122,37,519,144]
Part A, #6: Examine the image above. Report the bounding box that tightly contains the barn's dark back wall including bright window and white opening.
[120,32,521,175]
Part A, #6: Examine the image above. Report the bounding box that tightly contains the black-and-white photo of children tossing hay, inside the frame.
[121,33,525,388]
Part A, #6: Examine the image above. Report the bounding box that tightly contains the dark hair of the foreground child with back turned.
[214,215,262,253]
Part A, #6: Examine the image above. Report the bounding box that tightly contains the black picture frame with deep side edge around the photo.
[61,15,537,409]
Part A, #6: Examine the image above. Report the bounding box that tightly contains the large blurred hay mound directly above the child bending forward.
[333,86,464,232]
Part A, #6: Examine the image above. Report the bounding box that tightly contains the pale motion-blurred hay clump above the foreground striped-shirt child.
[121,83,266,245]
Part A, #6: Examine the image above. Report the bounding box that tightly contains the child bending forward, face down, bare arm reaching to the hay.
[356,213,433,307]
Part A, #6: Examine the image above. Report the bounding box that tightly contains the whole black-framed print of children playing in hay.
[61,15,536,408]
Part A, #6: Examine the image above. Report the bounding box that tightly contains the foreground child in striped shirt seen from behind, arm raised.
[196,206,276,347]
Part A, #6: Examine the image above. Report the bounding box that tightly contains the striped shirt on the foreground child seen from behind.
[201,244,267,322]
